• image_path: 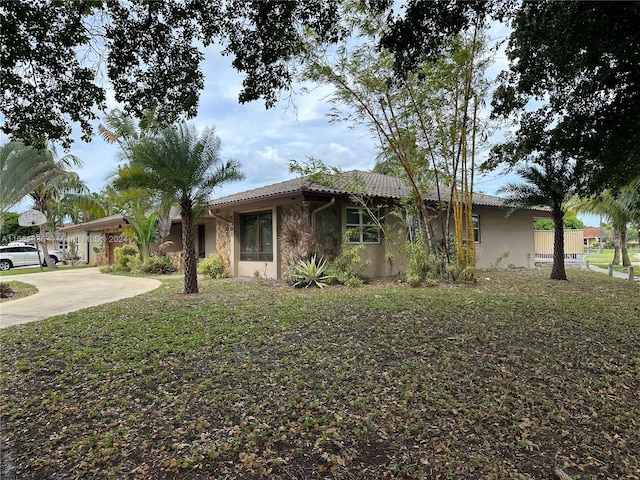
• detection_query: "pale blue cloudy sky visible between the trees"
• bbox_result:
[0,20,597,225]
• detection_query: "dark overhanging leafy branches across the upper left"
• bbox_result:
[0,0,339,148]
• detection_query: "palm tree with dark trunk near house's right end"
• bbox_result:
[500,157,575,280]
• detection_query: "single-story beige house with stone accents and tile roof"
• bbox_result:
[209,171,549,278]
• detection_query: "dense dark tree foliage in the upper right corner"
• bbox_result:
[492,1,640,194]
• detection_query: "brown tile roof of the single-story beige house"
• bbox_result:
[211,170,516,207]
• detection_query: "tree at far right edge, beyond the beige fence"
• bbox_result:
[576,186,640,267]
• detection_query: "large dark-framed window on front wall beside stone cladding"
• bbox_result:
[240,212,273,262]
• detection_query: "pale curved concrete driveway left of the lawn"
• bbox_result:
[0,268,160,328]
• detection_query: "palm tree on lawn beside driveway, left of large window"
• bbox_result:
[113,123,243,294]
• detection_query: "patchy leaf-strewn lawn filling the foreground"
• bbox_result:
[0,270,640,479]
